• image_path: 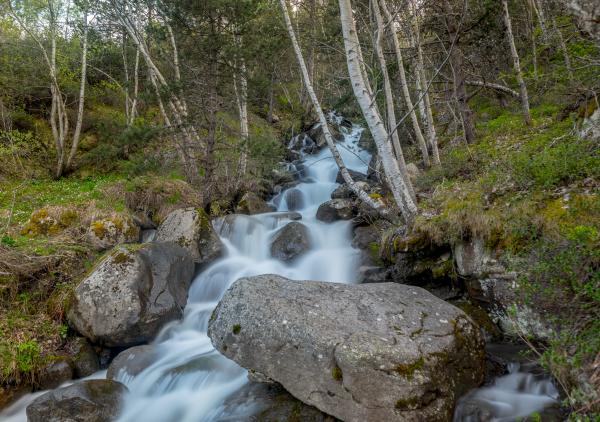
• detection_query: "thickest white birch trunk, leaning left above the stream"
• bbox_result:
[338,0,418,225]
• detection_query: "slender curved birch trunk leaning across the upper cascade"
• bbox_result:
[279,0,386,215]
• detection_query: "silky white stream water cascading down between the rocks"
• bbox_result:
[0,116,552,422]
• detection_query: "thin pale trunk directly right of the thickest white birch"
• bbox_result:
[371,0,416,201]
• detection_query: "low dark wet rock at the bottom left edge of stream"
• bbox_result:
[27,380,127,422]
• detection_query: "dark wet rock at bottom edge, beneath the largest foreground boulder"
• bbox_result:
[217,382,337,422]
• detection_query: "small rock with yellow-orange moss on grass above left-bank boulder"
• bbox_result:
[87,214,140,251]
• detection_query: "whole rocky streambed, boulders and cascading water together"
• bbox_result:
[0,114,560,422]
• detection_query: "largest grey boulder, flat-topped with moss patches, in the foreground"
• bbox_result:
[208,275,484,422]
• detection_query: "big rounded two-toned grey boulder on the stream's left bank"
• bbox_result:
[67,242,194,347]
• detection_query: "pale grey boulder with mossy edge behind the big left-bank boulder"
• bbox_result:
[154,208,224,265]
